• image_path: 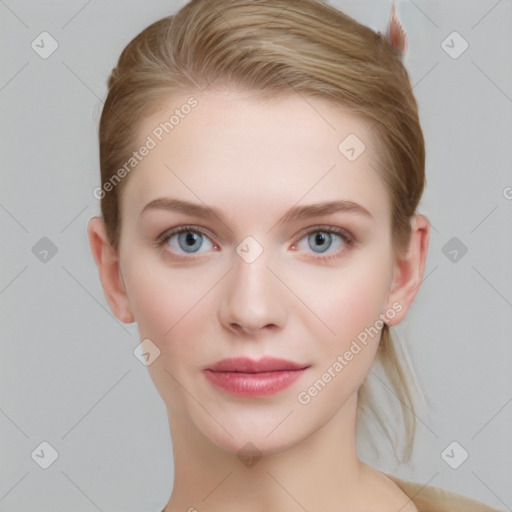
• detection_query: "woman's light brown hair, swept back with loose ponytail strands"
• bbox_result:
[99,0,425,460]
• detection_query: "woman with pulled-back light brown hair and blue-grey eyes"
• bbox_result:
[89,0,504,512]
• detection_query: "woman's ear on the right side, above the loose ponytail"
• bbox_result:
[386,215,430,325]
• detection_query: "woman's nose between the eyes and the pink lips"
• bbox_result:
[218,252,287,335]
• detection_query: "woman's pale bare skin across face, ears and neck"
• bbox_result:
[88,91,430,512]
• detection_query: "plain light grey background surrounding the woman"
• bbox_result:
[0,0,512,512]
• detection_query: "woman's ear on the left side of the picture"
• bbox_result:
[87,217,135,324]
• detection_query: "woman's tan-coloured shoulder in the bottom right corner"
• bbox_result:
[383,473,502,512]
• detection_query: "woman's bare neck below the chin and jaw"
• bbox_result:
[165,394,372,512]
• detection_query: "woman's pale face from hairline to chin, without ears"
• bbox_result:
[114,92,414,453]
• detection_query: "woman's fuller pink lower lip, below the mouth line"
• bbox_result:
[205,368,306,396]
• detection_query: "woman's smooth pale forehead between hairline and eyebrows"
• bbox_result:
[121,92,390,226]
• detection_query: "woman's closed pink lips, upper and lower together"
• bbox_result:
[204,356,309,396]
